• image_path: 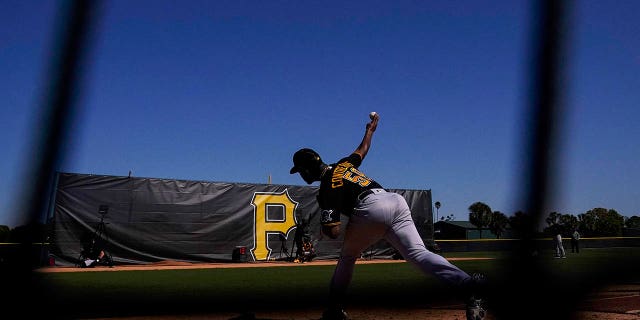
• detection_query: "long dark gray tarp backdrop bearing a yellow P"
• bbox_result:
[50,173,433,265]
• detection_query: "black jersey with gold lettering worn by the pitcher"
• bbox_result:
[318,153,382,215]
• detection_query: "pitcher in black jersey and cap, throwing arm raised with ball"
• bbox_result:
[290,112,485,319]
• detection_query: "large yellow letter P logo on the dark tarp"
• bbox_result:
[250,189,298,261]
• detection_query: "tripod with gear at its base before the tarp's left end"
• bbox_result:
[76,205,113,268]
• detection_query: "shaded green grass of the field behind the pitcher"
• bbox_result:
[35,248,640,318]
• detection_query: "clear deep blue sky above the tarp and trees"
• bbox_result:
[0,0,640,226]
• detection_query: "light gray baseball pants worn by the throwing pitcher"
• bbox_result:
[330,189,470,302]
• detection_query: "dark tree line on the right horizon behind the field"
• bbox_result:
[469,202,640,238]
